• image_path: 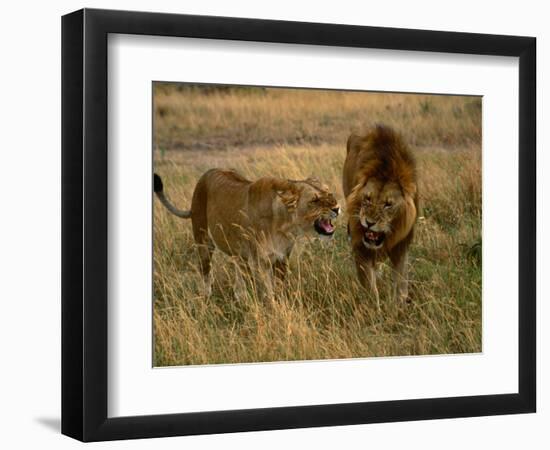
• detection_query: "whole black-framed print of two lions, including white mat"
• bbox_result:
[62,9,536,441]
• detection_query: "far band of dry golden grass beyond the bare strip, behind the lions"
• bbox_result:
[155,84,481,150]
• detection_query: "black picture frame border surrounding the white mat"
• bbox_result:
[62,9,536,441]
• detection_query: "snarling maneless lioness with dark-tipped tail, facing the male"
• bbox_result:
[154,169,340,298]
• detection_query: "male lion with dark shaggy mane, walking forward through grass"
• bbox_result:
[343,125,418,308]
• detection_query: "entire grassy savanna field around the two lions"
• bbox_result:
[154,84,481,366]
